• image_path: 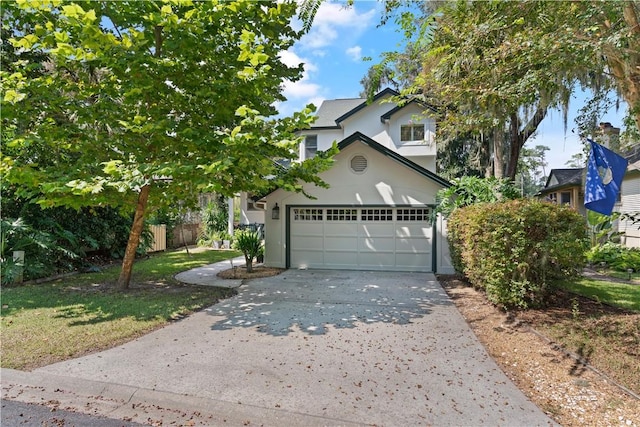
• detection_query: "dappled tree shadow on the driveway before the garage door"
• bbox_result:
[210,270,451,336]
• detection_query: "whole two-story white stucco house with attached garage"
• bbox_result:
[236,89,454,273]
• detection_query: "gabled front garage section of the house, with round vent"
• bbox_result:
[265,133,453,273]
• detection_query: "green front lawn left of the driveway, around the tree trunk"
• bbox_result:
[0,250,240,369]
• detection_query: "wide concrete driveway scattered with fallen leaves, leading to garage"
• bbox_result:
[27,270,553,426]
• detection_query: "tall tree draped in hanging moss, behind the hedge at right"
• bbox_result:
[378,0,640,179]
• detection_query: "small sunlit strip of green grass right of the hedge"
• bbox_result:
[560,277,640,312]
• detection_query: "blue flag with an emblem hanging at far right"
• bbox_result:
[584,139,629,215]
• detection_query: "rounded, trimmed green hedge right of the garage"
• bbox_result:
[448,199,589,308]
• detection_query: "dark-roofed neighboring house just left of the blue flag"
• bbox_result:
[537,168,586,215]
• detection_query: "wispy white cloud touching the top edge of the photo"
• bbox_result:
[300,2,377,49]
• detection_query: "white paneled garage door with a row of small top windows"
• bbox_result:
[289,207,433,271]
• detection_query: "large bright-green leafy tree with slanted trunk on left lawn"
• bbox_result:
[2,0,336,288]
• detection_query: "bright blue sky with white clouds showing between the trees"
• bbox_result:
[277,0,625,174]
